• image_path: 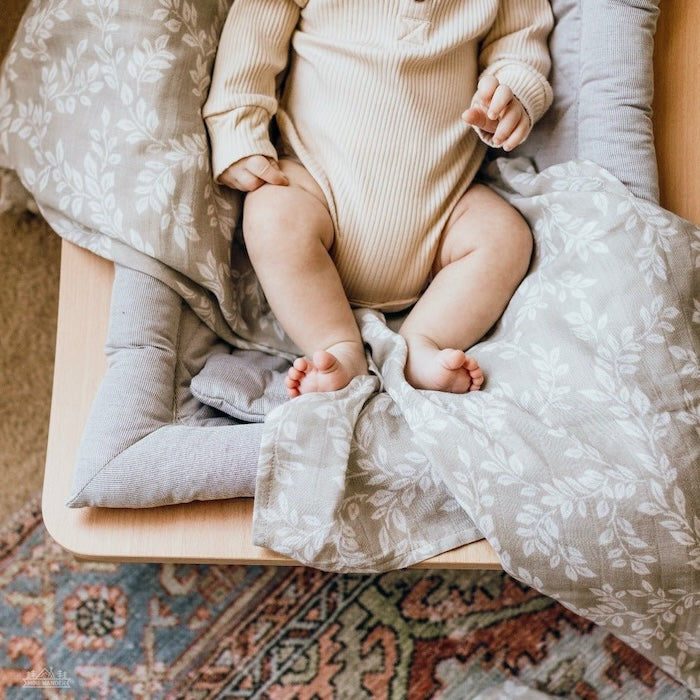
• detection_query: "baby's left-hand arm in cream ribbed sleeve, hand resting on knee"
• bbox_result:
[202,0,307,185]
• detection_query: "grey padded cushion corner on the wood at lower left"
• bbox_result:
[68,265,262,508]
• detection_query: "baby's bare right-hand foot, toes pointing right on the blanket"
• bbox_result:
[405,339,484,394]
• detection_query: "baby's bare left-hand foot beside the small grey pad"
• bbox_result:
[285,343,367,398]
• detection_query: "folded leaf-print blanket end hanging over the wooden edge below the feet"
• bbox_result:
[253,318,481,571]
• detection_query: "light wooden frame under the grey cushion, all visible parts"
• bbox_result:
[42,0,700,569]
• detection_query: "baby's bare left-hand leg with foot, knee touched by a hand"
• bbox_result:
[243,159,367,397]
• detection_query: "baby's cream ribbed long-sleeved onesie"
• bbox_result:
[203,0,552,310]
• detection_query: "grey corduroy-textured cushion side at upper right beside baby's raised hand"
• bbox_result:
[513,0,659,202]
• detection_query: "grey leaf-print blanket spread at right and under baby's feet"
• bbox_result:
[254,159,700,687]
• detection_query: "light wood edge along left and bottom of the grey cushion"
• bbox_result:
[42,241,500,568]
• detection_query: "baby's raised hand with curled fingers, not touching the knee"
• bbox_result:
[462,75,530,151]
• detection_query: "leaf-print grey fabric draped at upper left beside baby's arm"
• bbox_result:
[0,0,294,356]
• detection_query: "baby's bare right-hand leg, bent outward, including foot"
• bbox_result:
[400,185,532,393]
